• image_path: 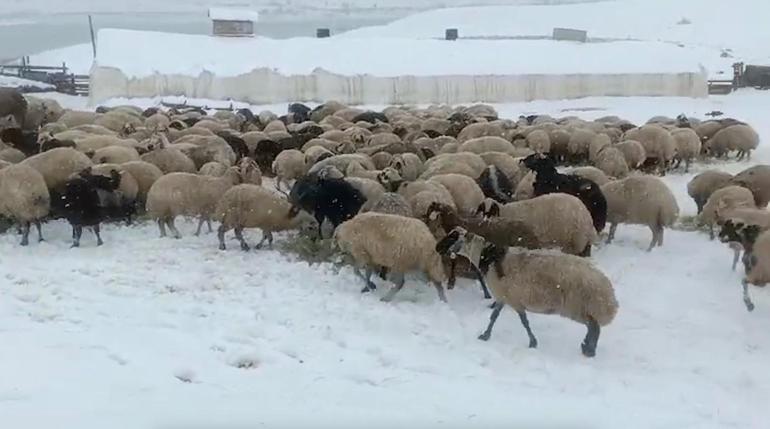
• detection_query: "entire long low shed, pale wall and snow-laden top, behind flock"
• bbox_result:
[91,30,707,104]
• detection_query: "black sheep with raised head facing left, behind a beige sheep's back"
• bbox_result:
[521,154,607,232]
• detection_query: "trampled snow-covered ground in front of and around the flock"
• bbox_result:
[0,91,770,429]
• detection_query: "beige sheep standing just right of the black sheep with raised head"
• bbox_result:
[601,175,679,252]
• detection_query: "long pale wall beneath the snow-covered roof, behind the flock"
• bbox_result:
[91,67,708,104]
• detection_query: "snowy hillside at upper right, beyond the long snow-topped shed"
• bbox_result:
[337,0,770,76]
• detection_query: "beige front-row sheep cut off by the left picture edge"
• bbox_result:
[0,164,51,246]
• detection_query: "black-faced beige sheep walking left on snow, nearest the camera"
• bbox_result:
[439,230,618,357]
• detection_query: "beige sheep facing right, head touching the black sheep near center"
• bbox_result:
[215,183,318,251]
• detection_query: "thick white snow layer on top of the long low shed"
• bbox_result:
[96,29,700,77]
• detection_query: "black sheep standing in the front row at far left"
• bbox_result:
[61,168,120,247]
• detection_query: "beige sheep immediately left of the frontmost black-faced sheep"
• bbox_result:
[334,212,446,302]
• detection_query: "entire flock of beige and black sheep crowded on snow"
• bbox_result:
[0,89,770,357]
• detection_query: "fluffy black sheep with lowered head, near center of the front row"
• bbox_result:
[289,175,366,239]
